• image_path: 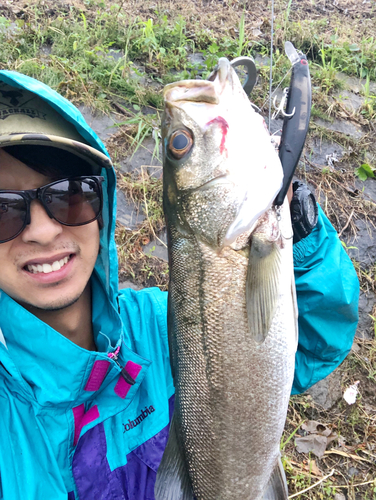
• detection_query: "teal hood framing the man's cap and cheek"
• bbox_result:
[0,71,118,308]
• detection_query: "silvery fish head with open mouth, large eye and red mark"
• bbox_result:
[162,58,283,246]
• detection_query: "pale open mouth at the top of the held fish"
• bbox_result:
[163,57,237,104]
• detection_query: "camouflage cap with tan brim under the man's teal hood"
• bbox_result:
[0,82,112,174]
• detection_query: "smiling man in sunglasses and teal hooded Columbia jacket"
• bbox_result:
[0,71,358,500]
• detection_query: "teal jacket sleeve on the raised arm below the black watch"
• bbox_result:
[292,206,359,394]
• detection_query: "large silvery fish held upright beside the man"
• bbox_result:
[154,58,297,500]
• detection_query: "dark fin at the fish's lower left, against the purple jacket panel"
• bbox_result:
[154,413,194,500]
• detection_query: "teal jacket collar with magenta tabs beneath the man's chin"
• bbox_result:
[0,275,150,408]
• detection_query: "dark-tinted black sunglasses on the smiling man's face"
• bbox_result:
[0,175,104,243]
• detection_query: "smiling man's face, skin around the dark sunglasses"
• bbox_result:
[0,149,99,310]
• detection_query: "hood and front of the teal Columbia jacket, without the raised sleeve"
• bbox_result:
[0,71,174,500]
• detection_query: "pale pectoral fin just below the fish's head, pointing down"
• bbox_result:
[246,235,281,342]
